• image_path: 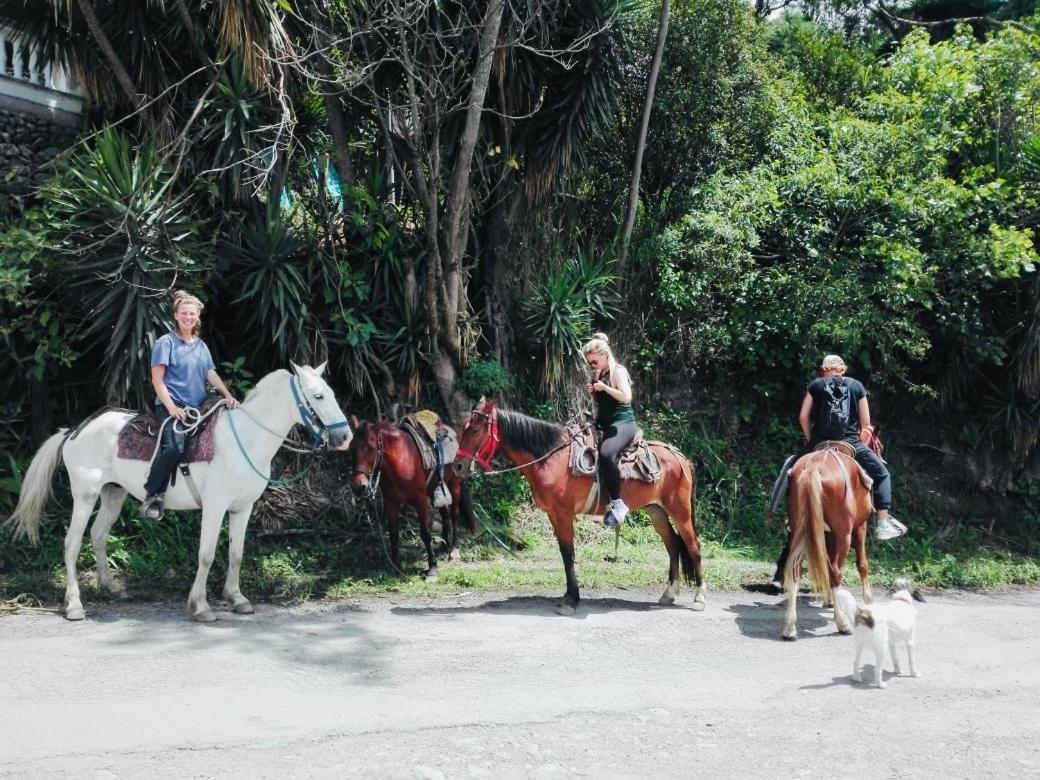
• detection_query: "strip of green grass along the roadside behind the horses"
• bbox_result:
[0,434,1040,605]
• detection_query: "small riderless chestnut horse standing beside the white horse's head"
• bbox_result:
[347,417,476,579]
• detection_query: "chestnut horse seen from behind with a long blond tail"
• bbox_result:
[783,442,874,640]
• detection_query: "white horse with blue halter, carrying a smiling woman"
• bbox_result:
[6,363,352,623]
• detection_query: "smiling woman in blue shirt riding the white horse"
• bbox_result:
[140,290,238,520]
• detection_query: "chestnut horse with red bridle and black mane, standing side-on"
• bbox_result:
[456,400,705,615]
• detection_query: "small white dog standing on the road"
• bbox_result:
[848,578,925,687]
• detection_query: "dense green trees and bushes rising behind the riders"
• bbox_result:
[0,0,1040,599]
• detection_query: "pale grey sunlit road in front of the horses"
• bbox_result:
[0,591,1040,779]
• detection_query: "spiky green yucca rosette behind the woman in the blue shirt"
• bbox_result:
[41,128,211,404]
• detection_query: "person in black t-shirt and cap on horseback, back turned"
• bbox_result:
[765,355,907,586]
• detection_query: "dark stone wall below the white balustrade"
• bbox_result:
[0,109,79,200]
